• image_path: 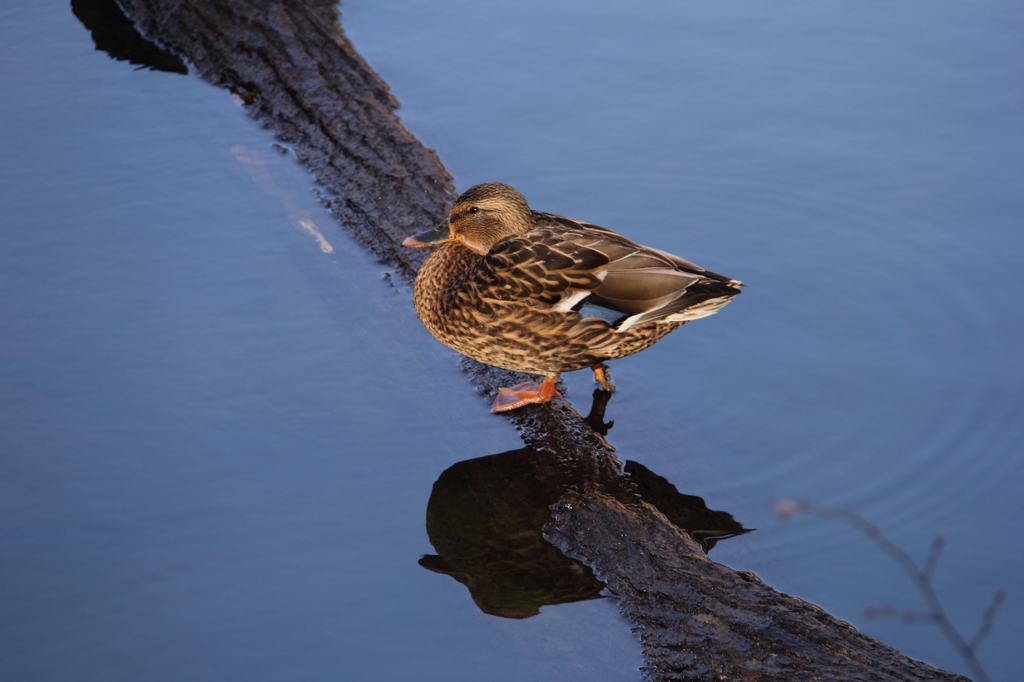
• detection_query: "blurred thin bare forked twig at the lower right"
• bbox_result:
[775,500,1006,682]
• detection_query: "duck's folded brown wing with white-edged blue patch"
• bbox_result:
[483,213,740,331]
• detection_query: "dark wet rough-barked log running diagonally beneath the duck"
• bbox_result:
[121,0,967,681]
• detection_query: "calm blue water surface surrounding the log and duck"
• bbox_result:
[0,1,1024,680]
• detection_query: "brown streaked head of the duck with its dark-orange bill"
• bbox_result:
[401,182,534,256]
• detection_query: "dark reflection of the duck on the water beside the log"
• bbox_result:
[420,390,750,619]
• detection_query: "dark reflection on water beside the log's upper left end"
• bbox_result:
[71,0,188,74]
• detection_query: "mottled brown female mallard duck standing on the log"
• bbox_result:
[402,182,742,412]
